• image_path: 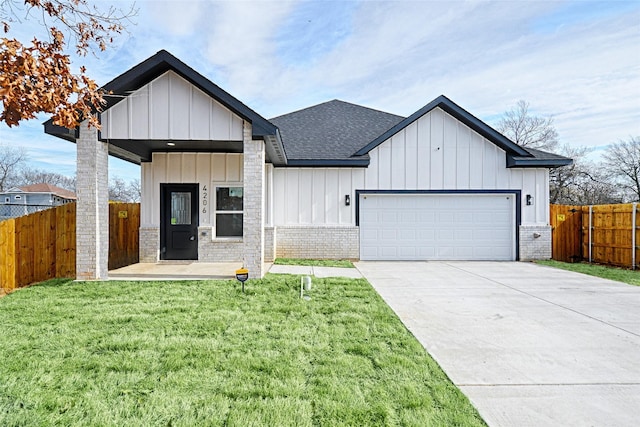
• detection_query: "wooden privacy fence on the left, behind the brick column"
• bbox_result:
[0,203,140,291]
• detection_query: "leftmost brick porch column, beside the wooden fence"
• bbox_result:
[76,121,109,280]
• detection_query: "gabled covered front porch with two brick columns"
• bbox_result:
[45,51,286,280]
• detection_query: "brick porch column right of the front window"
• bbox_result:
[242,122,265,279]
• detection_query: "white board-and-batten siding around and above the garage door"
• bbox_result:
[273,108,549,226]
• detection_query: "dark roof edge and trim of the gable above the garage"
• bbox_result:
[354,95,572,167]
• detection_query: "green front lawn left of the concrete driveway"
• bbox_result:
[0,275,485,427]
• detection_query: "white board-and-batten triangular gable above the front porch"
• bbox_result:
[102,71,242,141]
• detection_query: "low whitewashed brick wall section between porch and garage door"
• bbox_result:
[275,226,360,259]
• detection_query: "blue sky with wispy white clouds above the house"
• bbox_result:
[0,0,640,179]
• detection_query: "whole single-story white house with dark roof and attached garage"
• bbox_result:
[45,51,571,278]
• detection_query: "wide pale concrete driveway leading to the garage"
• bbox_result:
[356,262,640,427]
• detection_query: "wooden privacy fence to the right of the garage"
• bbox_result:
[550,203,640,269]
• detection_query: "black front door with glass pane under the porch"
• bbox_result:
[160,184,198,260]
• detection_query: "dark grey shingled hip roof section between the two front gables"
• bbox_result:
[270,99,403,166]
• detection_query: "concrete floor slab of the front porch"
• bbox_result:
[109,261,252,280]
